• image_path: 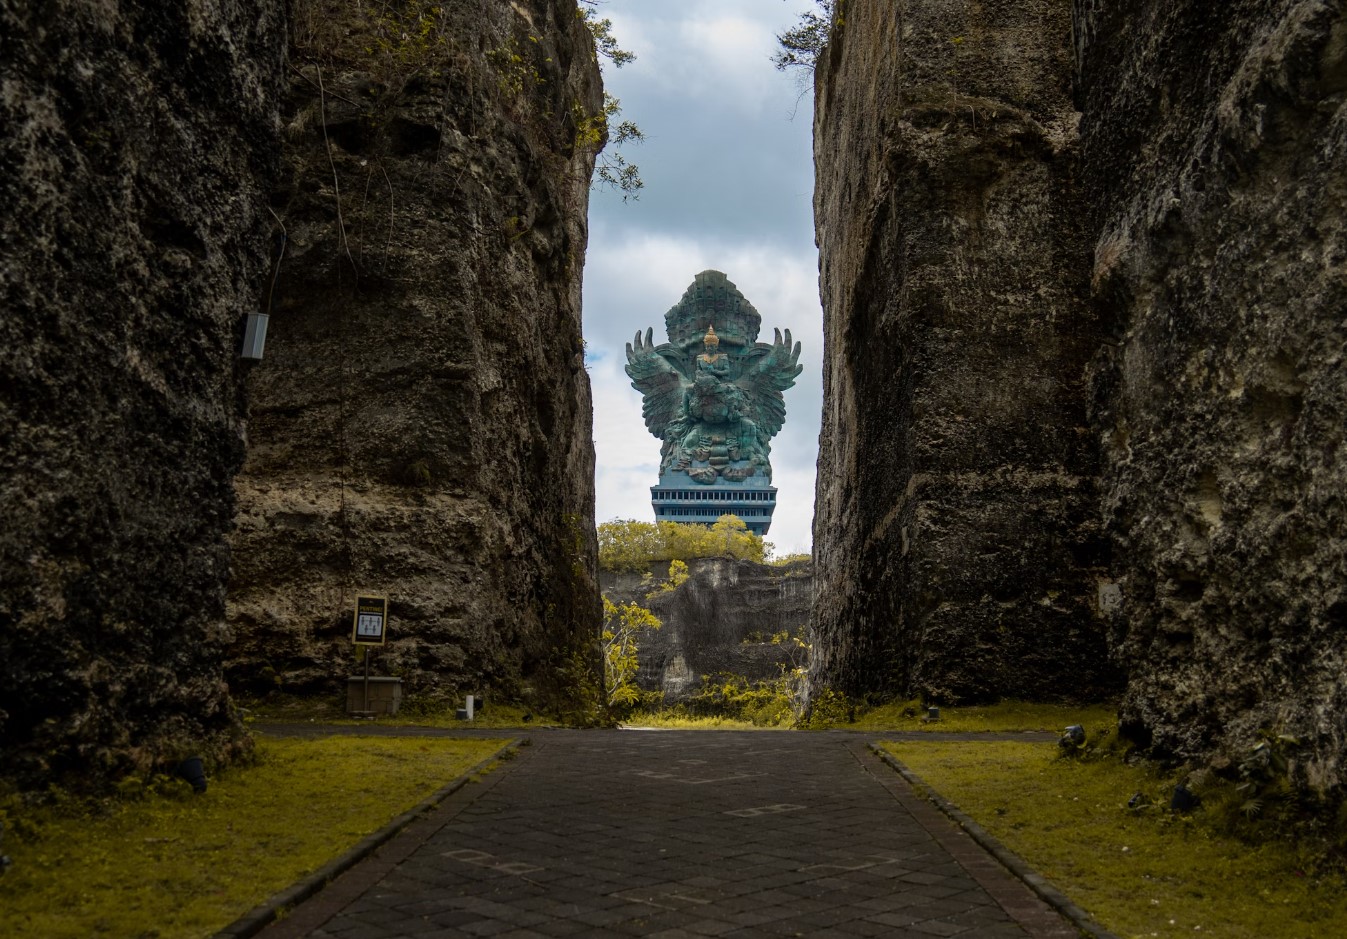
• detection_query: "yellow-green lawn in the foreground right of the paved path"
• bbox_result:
[884,741,1347,939]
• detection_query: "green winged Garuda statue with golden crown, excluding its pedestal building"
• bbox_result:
[626,271,803,485]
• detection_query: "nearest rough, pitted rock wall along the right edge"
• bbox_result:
[1076,0,1347,788]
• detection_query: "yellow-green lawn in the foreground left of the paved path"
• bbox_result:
[0,737,505,939]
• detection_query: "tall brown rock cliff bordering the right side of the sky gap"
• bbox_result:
[812,0,1115,703]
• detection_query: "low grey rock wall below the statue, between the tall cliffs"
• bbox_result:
[601,558,814,705]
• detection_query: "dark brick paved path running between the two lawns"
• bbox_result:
[261,732,1076,939]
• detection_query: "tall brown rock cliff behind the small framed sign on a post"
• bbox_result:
[229,0,602,711]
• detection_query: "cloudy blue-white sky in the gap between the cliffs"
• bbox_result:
[585,0,823,555]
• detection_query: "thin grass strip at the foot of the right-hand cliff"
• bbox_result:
[834,701,1118,733]
